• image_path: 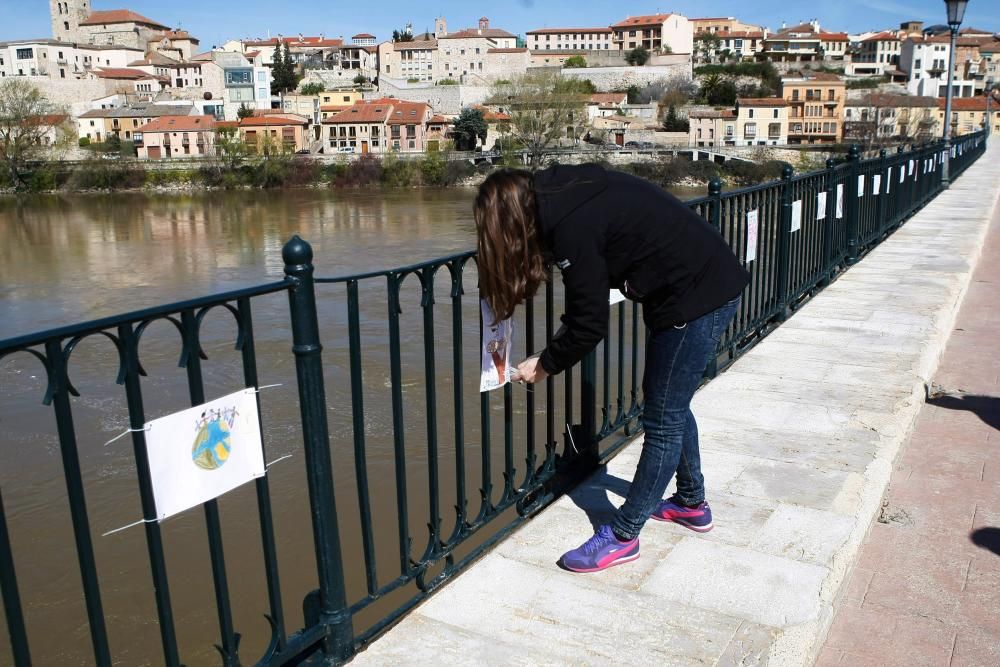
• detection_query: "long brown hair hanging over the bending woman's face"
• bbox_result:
[474,169,548,324]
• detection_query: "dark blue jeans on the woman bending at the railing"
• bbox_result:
[611,297,740,539]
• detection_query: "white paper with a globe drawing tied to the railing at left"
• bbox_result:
[145,389,265,521]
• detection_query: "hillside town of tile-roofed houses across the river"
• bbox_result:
[0,0,1000,183]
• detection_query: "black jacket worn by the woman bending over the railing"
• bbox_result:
[535,164,750,373]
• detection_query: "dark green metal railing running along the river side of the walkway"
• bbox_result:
[0,133,985,667]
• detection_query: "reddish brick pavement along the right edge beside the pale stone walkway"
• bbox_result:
[817,168,1000,667]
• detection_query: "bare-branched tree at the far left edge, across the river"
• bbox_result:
[0,77,68,189]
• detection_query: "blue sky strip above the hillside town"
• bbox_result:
[0,0,1000,49]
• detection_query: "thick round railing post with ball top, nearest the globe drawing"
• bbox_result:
[281,235,354,663]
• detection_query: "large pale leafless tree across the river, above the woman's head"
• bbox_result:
[488,72,593,168]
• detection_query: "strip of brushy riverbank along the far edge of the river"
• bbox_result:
[0,153,796,195]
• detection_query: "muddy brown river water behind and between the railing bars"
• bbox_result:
[0,184,699,665]
